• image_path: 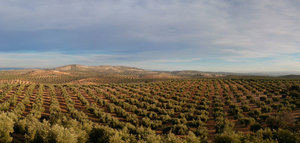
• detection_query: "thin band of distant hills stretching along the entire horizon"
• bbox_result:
[0,64,300,77]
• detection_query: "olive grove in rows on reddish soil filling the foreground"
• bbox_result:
[0,78,300,142]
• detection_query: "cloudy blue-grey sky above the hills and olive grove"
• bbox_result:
[0,0,300,72]
